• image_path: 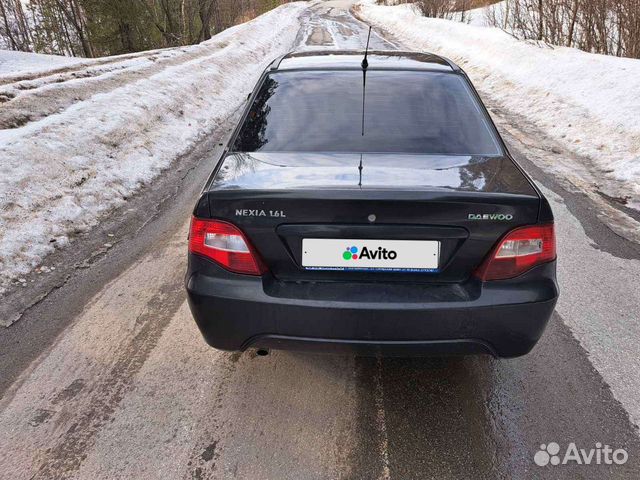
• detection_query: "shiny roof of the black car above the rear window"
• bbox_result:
[270,50,460,72]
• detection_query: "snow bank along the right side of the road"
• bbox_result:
[356,0,640,198]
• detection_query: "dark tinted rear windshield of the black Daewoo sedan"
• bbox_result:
[234,70,500,156]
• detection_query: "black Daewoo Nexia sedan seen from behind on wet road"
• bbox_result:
[186,51,558,357]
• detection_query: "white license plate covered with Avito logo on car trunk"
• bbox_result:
[302,238,440,272]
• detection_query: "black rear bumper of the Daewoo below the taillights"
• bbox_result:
[186,255,558,357]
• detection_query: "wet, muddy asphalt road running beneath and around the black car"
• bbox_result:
[0,1,640,480]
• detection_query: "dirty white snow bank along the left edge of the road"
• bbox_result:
[0,3,306,293]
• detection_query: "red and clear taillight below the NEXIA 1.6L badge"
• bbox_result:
[189,217,267,275]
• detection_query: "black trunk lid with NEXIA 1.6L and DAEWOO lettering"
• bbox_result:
[207,153,540,282]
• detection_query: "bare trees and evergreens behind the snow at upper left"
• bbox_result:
[0,0,292,57]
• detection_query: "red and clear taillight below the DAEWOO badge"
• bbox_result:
[475,224,556,282]
